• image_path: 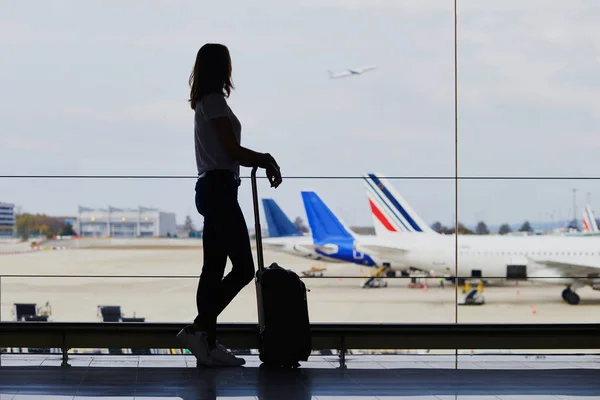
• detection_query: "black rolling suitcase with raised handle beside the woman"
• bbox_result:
[251,167,312,367]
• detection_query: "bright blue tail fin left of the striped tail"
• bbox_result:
[302,192,354,243]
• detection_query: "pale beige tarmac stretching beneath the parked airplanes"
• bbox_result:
[0,246,600,323]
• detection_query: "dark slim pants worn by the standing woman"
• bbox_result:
[194,171,254,345]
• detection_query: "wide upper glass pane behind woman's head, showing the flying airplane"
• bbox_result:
[0,0,453,175]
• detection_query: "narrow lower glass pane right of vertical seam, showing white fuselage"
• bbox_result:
[458,180,600,323]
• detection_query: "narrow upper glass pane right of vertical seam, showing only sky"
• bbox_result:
[458,1,600,177]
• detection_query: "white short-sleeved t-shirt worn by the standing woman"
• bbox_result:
[194,93,242,177]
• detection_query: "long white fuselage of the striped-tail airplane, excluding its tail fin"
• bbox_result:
[359,233,600,284]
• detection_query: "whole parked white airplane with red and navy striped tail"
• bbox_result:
[357,174,600,305]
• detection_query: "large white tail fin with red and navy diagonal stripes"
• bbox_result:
[363,174,435,235]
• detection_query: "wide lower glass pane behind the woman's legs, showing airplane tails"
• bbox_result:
[0,175,455,322]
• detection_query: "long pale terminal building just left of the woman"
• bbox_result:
[77,206,177,238]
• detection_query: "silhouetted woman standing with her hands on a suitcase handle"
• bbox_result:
[177,43,282,366]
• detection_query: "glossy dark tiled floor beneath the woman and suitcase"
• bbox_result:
[0,355,600,400]
